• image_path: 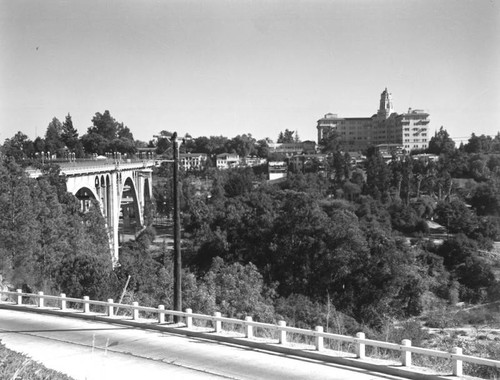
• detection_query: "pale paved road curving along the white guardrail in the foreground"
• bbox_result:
[0,309,406,380]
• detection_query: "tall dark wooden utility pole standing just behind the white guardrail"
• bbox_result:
[171,132,182,323]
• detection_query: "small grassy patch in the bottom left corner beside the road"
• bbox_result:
[0,341,73,380]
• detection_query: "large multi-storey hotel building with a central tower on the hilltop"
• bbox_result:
[317,88,429,152]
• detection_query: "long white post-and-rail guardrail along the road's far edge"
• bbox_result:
[0,289,500,376]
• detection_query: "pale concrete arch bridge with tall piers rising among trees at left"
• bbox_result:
[28,159,156,262]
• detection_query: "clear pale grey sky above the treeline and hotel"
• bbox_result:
[0,0,500,143]
